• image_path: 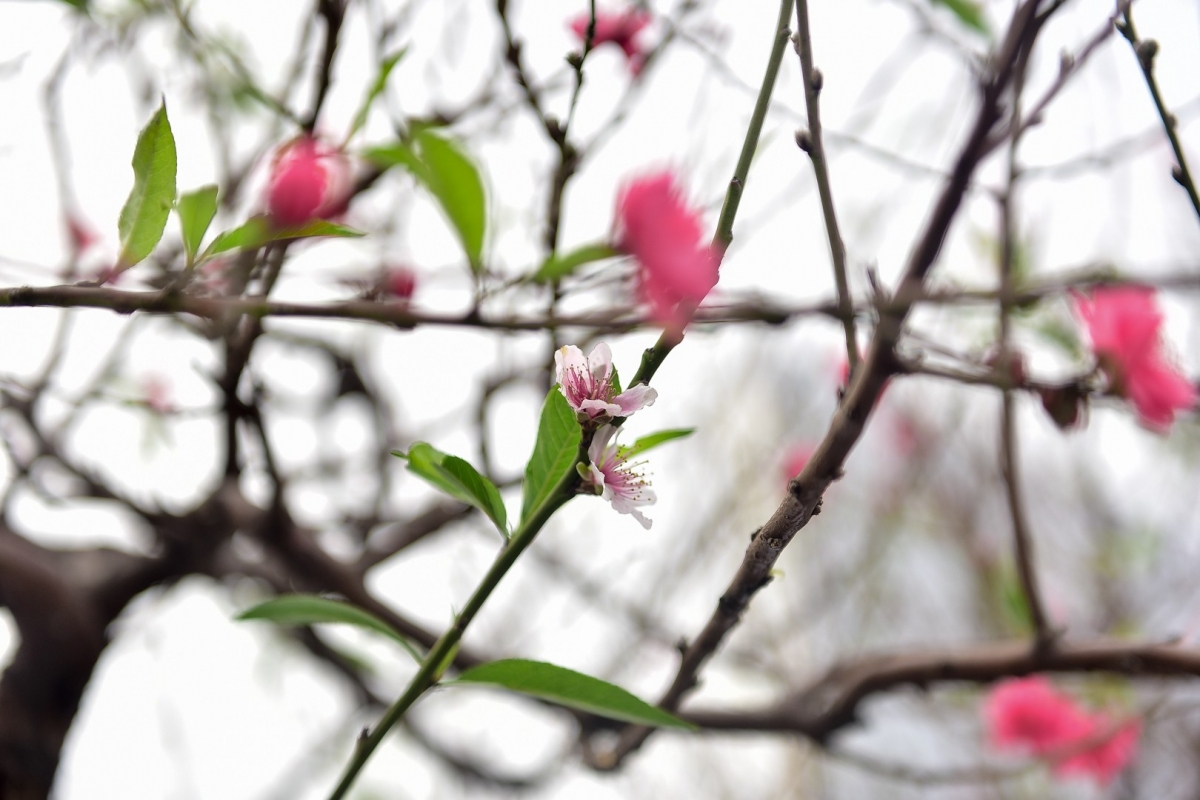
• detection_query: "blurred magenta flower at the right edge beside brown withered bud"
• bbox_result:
[1074,287,1196,433]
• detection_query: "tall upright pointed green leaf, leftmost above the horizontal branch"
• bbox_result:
[116,103,176,269]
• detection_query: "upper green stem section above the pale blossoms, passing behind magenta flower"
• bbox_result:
[629,0,794,386]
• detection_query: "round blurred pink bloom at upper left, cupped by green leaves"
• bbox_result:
[266,136,350,228]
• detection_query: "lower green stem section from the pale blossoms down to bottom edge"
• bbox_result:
[329,434,592,800]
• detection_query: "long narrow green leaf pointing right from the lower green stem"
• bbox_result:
[446,658,696,730]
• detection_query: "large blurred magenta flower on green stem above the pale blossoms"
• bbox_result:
[616,172,721,336]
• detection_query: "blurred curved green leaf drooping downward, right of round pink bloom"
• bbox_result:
[365,130,487,272]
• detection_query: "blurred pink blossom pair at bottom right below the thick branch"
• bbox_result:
[984,675,1141,784]
